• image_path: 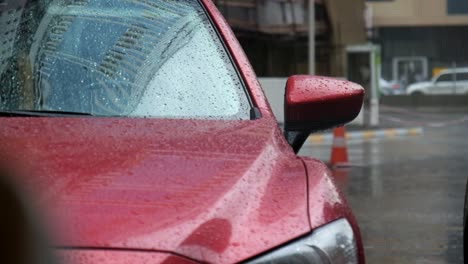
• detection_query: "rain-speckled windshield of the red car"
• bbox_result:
[0,0,250,119]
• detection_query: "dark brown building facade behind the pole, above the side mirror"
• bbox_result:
[214,0,366,77]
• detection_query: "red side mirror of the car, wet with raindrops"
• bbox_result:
[284,75,364,153]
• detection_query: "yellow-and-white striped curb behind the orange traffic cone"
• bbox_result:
[307,127,424,144]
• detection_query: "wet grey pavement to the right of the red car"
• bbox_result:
[300,108,468,264]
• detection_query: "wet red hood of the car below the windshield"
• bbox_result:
[0,117,310,263]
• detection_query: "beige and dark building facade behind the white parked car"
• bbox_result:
[367,0,468,85]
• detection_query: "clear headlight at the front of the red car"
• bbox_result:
[247,219,358,264]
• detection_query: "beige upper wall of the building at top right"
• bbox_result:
[367,0,468,27]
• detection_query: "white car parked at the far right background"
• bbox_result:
[406,68,468,95]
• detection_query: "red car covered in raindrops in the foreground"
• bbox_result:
[0,0,364,264]
